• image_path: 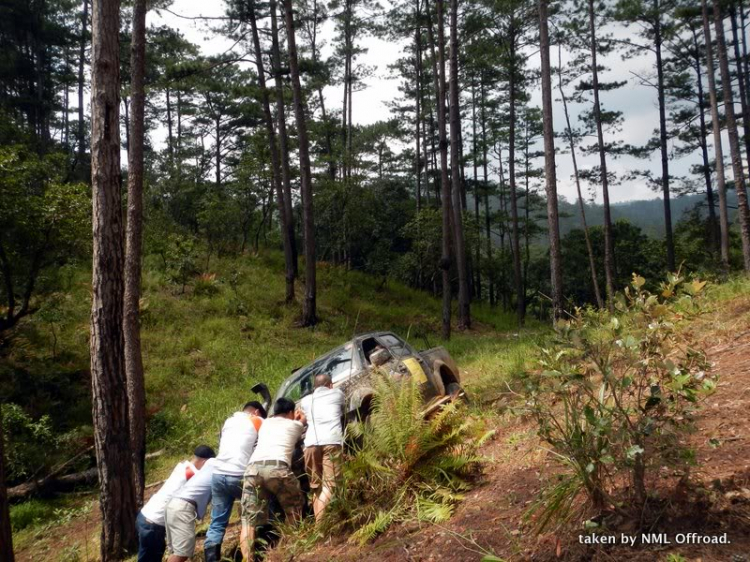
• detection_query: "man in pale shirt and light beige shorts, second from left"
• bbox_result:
[164,459,216,562]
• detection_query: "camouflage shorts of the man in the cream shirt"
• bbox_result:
[240,464,304,527]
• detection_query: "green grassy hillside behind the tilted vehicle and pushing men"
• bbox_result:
[5,253,542,553]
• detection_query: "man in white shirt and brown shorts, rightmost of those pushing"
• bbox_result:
[300,374,346,521]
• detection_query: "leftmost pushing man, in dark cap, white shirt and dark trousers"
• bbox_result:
[135,445,216,562]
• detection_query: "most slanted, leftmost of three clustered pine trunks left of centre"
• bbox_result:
[248,0,295,303]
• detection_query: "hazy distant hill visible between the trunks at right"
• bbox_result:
[560,191,737,238]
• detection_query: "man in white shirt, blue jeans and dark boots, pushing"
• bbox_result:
[203,400,266,562]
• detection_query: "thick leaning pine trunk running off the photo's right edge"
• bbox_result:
[713,0,750,272]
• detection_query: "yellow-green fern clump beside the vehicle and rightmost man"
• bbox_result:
[325,375,492,543]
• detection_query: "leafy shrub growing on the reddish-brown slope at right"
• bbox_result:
[528,274,716,530]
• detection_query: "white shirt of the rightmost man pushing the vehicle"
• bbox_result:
[299,386,346,447]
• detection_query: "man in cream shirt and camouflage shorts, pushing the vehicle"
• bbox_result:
[238,398,305,562]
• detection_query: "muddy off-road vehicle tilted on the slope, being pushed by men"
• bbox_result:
[252,332,465,421]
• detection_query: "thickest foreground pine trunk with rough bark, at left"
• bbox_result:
[91,0,138,562]
